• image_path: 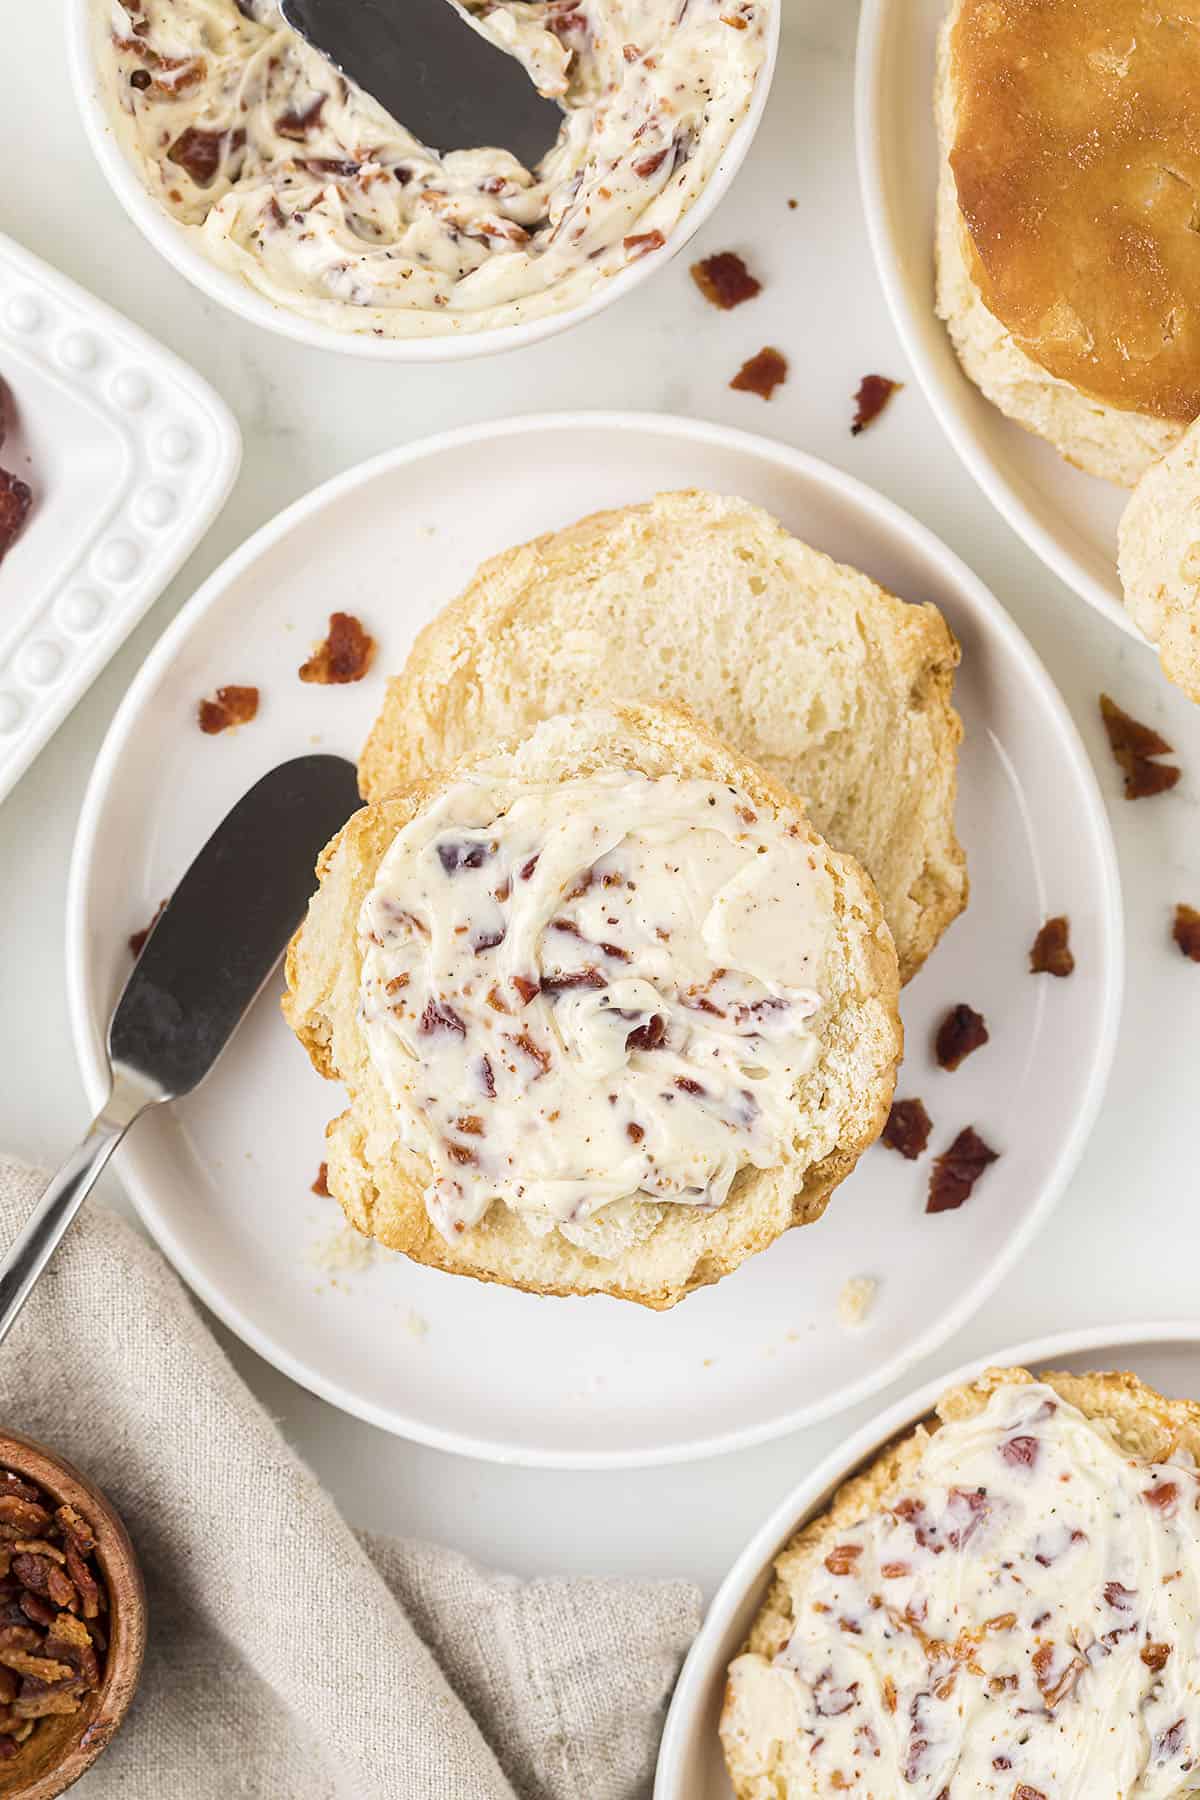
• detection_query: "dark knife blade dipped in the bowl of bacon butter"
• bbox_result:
[281,0,563,169]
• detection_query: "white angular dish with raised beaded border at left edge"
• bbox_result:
[0,234,241,797]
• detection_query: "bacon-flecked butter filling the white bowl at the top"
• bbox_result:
[94,0,774,337]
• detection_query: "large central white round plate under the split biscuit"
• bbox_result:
[68,414,1121,1467]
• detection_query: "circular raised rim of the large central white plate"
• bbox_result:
[67,410,1124,1469]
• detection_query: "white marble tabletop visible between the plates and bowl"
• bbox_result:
[0,0,1200,1586]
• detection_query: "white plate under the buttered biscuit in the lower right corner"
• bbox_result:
[653,1319,1200,1800]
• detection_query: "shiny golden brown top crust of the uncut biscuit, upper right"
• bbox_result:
[950,0,1200,423]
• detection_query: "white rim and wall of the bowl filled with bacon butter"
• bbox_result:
[67,0,783,362]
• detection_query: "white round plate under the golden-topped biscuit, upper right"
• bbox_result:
[855,0,1144,643]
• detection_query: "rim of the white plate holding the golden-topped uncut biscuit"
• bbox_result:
[855,0,1148,644]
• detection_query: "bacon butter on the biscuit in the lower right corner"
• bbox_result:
[734,1382,1200,1800]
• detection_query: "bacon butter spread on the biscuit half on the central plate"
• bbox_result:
[360,772,833,1247]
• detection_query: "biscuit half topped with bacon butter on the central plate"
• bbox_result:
[284,707,901,1309]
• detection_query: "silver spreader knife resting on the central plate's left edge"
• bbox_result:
[0,756,360,1341]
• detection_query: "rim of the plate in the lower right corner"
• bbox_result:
[653,1319,1200,1800]
